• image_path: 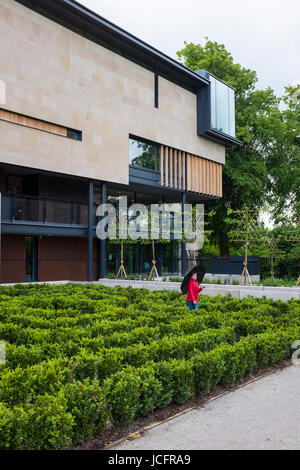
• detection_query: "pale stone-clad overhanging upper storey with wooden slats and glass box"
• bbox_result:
[0,0,237,197]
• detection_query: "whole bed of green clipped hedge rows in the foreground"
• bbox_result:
[0,284,300,449]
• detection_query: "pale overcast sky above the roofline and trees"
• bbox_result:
[80,0,300,95]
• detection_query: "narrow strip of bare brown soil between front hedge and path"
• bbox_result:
[72,359,292,450]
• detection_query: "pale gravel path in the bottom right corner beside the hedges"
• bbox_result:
[113,365,300,450]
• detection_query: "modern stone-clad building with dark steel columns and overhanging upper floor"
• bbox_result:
[0,0,238,283]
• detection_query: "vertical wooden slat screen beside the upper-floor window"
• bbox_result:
[160,145,222,197]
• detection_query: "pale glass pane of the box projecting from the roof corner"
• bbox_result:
[209,75,235,137]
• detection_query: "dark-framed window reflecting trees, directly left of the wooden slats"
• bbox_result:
[129,138,160,171]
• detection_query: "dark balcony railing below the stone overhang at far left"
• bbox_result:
[2,195,97,227]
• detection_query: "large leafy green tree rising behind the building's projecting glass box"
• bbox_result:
[177,38,299,256]
